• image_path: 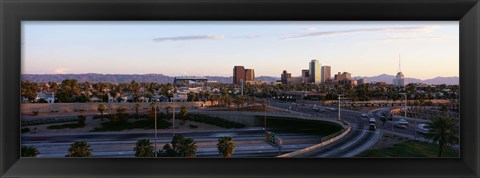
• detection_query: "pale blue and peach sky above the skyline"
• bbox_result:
[21,21,459,80]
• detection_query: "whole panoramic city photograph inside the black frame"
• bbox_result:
[18,21,461,159]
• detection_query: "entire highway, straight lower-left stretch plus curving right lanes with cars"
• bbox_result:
[22,100,436,157]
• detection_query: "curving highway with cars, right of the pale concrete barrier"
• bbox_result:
[270,100,427,157]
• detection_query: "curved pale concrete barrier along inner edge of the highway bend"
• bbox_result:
[276,122,352,158]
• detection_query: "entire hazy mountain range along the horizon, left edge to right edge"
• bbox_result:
[21,73,459,85]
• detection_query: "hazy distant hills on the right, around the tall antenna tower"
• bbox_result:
[354,74,460,85]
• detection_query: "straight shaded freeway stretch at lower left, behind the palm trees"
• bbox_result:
[22,128,321,157]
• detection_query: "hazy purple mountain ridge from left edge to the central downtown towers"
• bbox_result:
[21,73,278,83]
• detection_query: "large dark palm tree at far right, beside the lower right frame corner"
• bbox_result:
[425,116,459,157]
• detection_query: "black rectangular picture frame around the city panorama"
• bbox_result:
[0,0,480,177]
